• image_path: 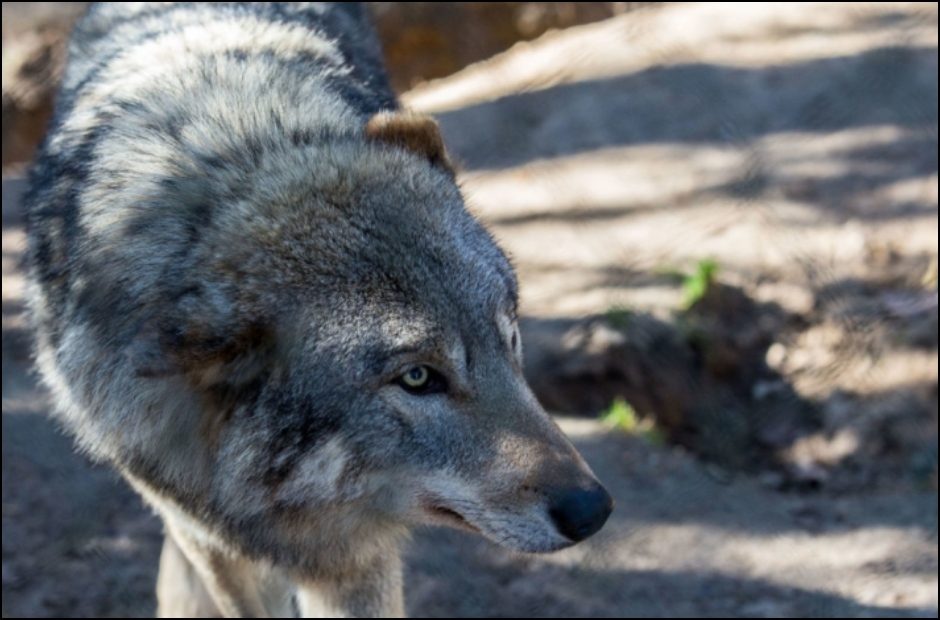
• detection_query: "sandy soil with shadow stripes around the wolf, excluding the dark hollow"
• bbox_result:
[3,4,938,617]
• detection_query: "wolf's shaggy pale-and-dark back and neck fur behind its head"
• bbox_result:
[25,3,397,456]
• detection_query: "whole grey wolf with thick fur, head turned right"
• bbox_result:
[25,3,612,616]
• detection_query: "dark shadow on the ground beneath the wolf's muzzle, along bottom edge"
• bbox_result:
[406,530,935,618]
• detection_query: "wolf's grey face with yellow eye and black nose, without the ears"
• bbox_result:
[231,117,612,552]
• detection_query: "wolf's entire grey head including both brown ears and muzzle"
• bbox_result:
[129,113,612,564]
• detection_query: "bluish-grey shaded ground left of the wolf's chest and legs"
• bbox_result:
[3,400,162,617]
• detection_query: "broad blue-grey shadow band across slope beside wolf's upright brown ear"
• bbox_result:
[438,46,937,170]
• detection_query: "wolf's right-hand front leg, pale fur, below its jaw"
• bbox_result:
[297,554,405,618]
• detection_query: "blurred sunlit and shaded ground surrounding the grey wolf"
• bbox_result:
[2,2,938,617]
